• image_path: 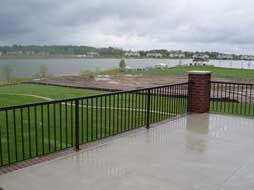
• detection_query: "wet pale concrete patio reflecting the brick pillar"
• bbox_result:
[0,114,254,190]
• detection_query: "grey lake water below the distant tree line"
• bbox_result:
[0,59,254,78]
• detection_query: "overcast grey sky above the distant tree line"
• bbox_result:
[0,0,254,54]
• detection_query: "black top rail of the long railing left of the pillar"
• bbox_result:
[0,82,189,111]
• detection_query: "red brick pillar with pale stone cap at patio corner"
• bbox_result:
[188,71,211,113]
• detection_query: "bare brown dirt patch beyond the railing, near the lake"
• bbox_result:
[29,75,236,90]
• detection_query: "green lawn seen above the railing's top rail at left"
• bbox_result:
[0,84,103,107]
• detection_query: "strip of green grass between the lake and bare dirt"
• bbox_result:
[126,66,254,78]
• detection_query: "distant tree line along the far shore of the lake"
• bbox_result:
[0,45,240,59]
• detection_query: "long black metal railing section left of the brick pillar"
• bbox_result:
[0,83,188,167]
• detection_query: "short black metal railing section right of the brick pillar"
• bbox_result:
[210,81,254,116]
